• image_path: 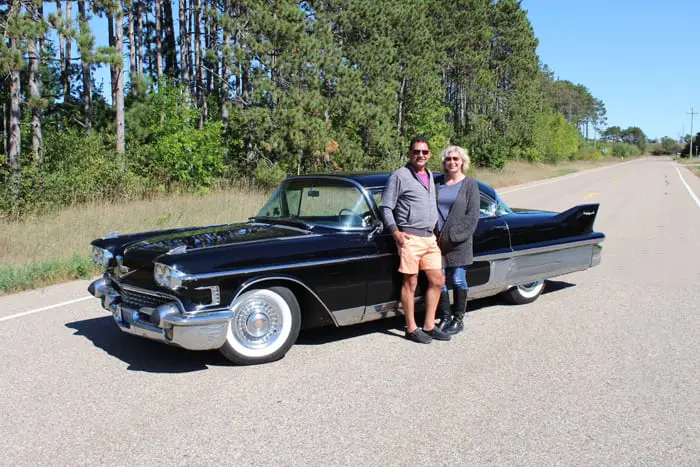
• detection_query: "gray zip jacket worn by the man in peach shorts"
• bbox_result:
[379,164,438,237]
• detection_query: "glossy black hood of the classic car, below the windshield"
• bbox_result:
[124,222,310,267]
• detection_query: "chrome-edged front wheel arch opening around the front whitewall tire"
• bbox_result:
[230,275,338,329]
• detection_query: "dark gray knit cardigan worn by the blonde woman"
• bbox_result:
[436,177,481,268]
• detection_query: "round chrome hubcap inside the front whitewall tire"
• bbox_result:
[232,299,284,349]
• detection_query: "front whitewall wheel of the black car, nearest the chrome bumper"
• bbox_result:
[219,287,301,365]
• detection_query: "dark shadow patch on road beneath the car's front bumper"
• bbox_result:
[66,316,229,373]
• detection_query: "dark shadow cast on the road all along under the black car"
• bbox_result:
[66,281,575,373]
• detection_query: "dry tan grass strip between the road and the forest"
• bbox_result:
[0,159,619,294]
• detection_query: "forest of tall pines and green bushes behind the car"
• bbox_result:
[0,0,624,217]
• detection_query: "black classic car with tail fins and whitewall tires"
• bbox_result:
[89,174,605,364]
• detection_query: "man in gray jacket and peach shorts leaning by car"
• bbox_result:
[379,136,450,344]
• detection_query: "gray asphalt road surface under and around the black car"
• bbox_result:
[0,159,700,465]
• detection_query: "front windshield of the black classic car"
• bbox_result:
[256,178,375,229]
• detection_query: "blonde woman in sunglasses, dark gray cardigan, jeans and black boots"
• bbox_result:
[436,146,479,334]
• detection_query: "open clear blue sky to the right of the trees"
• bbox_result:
[522,0,700,138]
